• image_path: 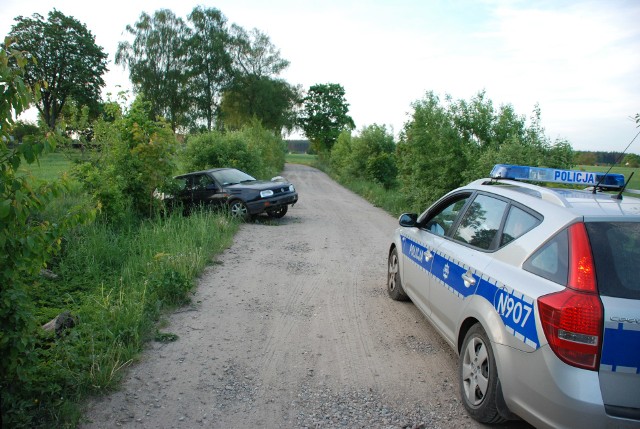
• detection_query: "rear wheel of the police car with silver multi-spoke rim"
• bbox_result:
[458,323,507,424]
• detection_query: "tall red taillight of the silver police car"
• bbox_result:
[538,223,603,370]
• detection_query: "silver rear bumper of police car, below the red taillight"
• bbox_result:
[494,344,640,428]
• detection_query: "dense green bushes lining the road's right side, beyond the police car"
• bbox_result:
[330,92,573,211]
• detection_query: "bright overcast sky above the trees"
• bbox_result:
[0,0,640,153]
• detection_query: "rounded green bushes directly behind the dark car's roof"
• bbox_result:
[182,122,285,178]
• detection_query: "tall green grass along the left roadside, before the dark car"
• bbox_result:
[10,211,238,427]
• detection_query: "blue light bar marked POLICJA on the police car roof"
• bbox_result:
[491,164,625,189]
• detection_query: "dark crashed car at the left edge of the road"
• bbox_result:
[165,168,298,220]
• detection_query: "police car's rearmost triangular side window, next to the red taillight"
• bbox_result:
[522,229,569,285]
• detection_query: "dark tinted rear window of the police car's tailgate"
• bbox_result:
[586,222,640,299]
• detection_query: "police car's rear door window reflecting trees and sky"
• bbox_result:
[453,195,508,250]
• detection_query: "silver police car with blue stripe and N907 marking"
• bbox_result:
[387,165,640,428]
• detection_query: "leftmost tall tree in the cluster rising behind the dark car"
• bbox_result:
[116,9,192,131]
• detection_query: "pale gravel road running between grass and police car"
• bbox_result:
[82,165,528,428]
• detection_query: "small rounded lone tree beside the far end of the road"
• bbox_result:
[300,83,355,152]
